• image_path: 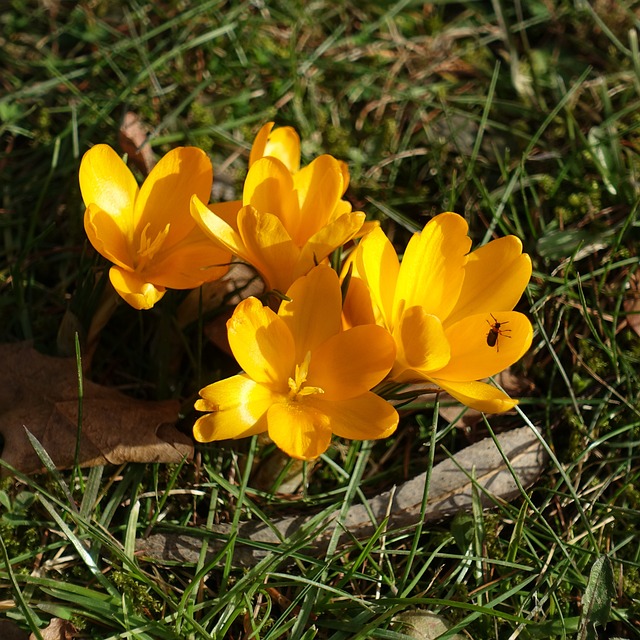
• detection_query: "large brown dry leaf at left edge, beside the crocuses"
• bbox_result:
[0,343,193,475]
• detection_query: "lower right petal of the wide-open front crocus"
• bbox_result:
[313,392,399,440]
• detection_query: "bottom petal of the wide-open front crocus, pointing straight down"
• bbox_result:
[267,402,331,460]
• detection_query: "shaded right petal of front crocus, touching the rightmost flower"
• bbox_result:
[307,324,396,402]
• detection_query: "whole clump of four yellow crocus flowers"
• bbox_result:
[80,123,533,460]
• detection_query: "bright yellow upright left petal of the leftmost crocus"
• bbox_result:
[79,144,138,237]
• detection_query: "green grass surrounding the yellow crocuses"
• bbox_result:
[0,0,640,640]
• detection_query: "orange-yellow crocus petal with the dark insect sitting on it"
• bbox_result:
[434,311,533,381]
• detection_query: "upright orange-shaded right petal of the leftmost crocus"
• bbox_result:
[134,147,213,244]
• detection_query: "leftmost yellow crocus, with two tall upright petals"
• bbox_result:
[80,144,231,309]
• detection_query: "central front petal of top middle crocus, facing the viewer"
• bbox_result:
[238,206,300,292]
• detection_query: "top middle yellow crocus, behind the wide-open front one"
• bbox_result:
[191,123,365,292]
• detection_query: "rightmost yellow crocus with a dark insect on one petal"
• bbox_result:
[345,213,533,413]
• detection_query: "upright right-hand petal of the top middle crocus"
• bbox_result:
[291,155,343,247]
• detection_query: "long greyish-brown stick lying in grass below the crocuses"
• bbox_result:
[138,427,547,565]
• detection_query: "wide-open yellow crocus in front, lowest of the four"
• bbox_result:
[193,265,398,460]
